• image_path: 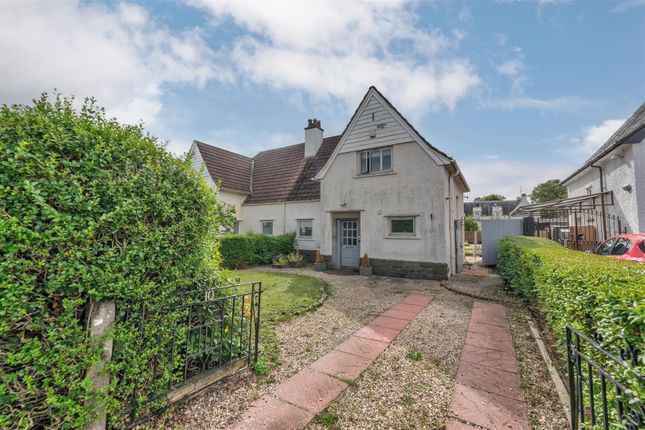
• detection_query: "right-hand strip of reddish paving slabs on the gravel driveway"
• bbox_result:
[446,301,530,430]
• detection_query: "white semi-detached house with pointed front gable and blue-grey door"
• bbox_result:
[192,87,469,279]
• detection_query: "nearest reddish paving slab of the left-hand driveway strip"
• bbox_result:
[231,394,314,430]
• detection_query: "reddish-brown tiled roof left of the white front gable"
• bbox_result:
[195,136,340,204]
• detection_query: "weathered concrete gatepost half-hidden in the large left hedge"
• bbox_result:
[85,302,116,430]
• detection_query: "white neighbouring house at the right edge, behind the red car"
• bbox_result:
[562,103,645,233]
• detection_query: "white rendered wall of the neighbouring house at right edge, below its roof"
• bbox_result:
[567,142,645,233]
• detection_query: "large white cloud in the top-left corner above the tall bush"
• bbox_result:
[0,2,232,124]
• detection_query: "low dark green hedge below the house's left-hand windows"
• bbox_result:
[219,233,296,268]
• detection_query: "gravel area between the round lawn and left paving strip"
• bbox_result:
[149,267,445,429]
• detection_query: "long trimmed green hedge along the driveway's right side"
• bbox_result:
[497,237,645,398]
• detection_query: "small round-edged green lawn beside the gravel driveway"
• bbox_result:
[230,270,328,322]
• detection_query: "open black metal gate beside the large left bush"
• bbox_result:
[114,282,262,427]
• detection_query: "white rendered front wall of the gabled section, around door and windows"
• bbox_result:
[320,142,450,264]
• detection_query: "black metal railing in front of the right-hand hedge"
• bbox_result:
[566,326,645,430]
